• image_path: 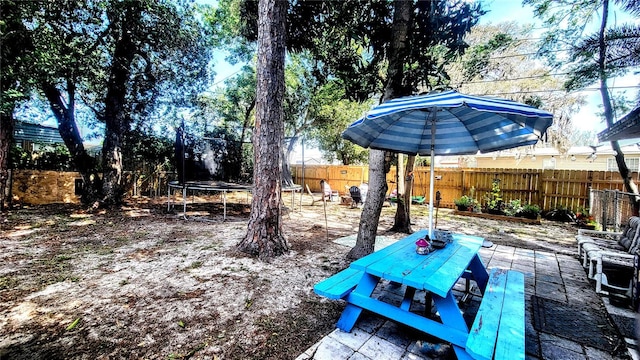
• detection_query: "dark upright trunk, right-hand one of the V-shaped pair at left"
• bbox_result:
[102,2,142,206]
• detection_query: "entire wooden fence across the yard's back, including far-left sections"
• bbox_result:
[10,165,638,211]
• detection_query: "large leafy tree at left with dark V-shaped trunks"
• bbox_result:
[3,0,210,204]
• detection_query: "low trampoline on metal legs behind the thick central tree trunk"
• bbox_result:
[167,181,302,220]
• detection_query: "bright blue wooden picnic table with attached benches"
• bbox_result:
[314,230,524,359]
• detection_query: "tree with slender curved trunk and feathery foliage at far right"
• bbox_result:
[524,0,640,213]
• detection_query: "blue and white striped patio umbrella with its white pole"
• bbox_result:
[342,91,553,236]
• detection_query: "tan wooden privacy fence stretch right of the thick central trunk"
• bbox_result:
[291,164,638,211]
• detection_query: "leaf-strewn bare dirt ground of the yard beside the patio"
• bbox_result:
[0,195,576,359]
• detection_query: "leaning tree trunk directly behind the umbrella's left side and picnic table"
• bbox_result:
[347,0,413,259]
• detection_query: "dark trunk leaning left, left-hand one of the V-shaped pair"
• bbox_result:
[41,81,100,205]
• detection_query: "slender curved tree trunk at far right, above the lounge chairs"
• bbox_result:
[598,0,640,215]
